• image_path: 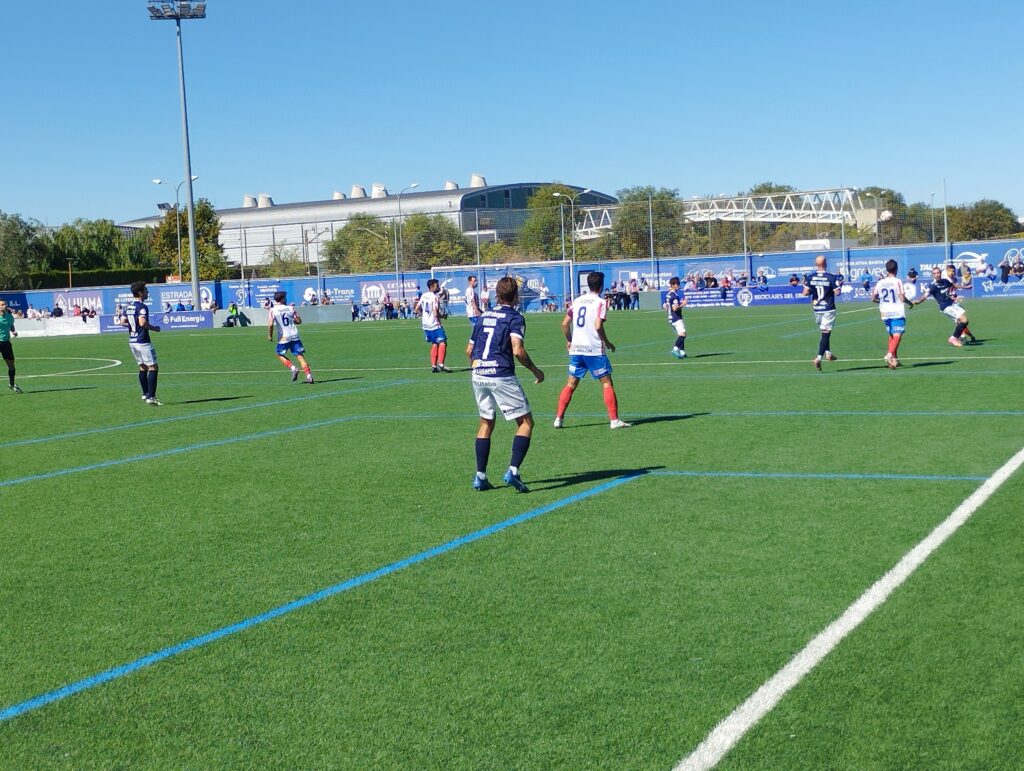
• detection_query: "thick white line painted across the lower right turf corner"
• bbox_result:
[676,449,1024,771]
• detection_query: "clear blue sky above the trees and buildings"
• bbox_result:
[0,0,1024,224]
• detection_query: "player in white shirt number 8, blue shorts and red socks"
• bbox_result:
[555,271,631,428]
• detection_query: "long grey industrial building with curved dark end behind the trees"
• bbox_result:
[122,174,617,267]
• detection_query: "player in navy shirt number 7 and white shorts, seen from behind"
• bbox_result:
[466,276,544,492]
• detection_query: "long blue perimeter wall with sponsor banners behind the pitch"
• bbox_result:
[0,240,1024,313]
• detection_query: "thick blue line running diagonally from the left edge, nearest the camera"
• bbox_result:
[0,471,646,723]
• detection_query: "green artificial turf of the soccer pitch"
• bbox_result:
[0,300,1024,769]
